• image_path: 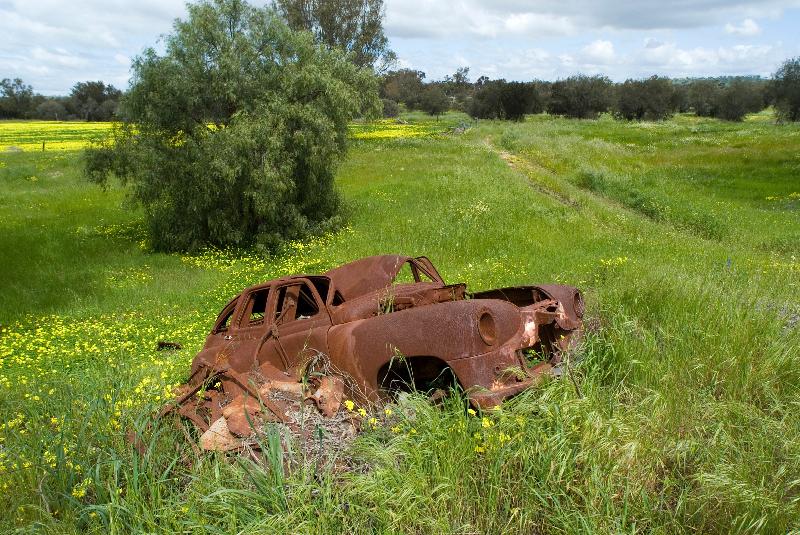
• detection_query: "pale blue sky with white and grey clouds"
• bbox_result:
[0,0,800,94]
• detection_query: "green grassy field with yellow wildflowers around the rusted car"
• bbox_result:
[0,114,800,534]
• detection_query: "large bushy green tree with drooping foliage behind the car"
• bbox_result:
[86,0,380,250]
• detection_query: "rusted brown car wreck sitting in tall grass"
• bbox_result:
[169,255,583,450]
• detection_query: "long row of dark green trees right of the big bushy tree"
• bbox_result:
[381,57,800,121]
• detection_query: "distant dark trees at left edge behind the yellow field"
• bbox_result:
[0,78,122,121]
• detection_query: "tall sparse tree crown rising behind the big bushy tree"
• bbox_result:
[275,0,397,72]
